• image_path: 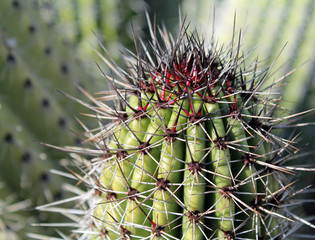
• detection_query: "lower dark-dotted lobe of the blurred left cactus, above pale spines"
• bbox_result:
[0,103,61,202]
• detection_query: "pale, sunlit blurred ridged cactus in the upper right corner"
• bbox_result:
[190,0,315,111]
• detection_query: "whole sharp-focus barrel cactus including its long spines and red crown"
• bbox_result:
[39,17,314,240]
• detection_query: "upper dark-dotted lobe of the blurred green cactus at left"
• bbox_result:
[0,0,99,148]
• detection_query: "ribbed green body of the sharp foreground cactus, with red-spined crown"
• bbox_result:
[85,32,286,239]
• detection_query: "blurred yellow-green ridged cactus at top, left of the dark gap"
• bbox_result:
[41,0,144,61]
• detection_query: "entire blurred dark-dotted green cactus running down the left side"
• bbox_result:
[0,0,102,239]
